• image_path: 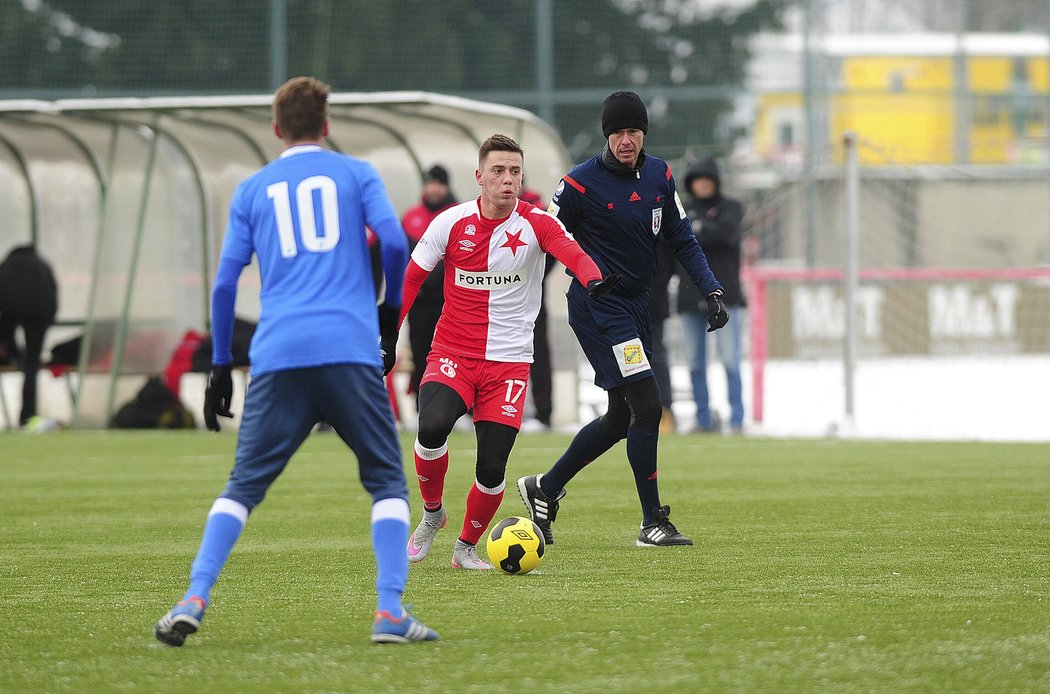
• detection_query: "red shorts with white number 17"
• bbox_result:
[419,349,529,430]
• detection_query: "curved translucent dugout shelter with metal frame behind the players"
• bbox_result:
[0,91,571,426]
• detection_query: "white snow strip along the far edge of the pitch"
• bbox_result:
[10,355,1050,442]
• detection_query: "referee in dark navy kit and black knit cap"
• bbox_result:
[518,91,729,547]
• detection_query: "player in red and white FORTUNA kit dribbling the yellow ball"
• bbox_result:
[401,134,620,569]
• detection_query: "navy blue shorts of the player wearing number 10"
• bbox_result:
[219,364,408,510]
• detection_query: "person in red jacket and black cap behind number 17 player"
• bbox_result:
[401,164,457,399]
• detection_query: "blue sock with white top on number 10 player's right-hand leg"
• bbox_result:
[372,499,408,617]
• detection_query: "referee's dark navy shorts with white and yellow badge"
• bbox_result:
[566,281,653,391]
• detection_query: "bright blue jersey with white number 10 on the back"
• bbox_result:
[222,145,404,374]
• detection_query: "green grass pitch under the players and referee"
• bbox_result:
[0,432,1050,693]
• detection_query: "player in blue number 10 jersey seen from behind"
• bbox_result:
[154,77,438,646]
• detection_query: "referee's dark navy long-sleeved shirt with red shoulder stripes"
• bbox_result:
[548,154,720,296]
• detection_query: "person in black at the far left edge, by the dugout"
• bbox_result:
[0,245,59,426]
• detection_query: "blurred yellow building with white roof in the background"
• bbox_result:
[754,34,1050,165]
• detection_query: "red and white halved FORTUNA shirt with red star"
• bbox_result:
[401,193,602,362]
